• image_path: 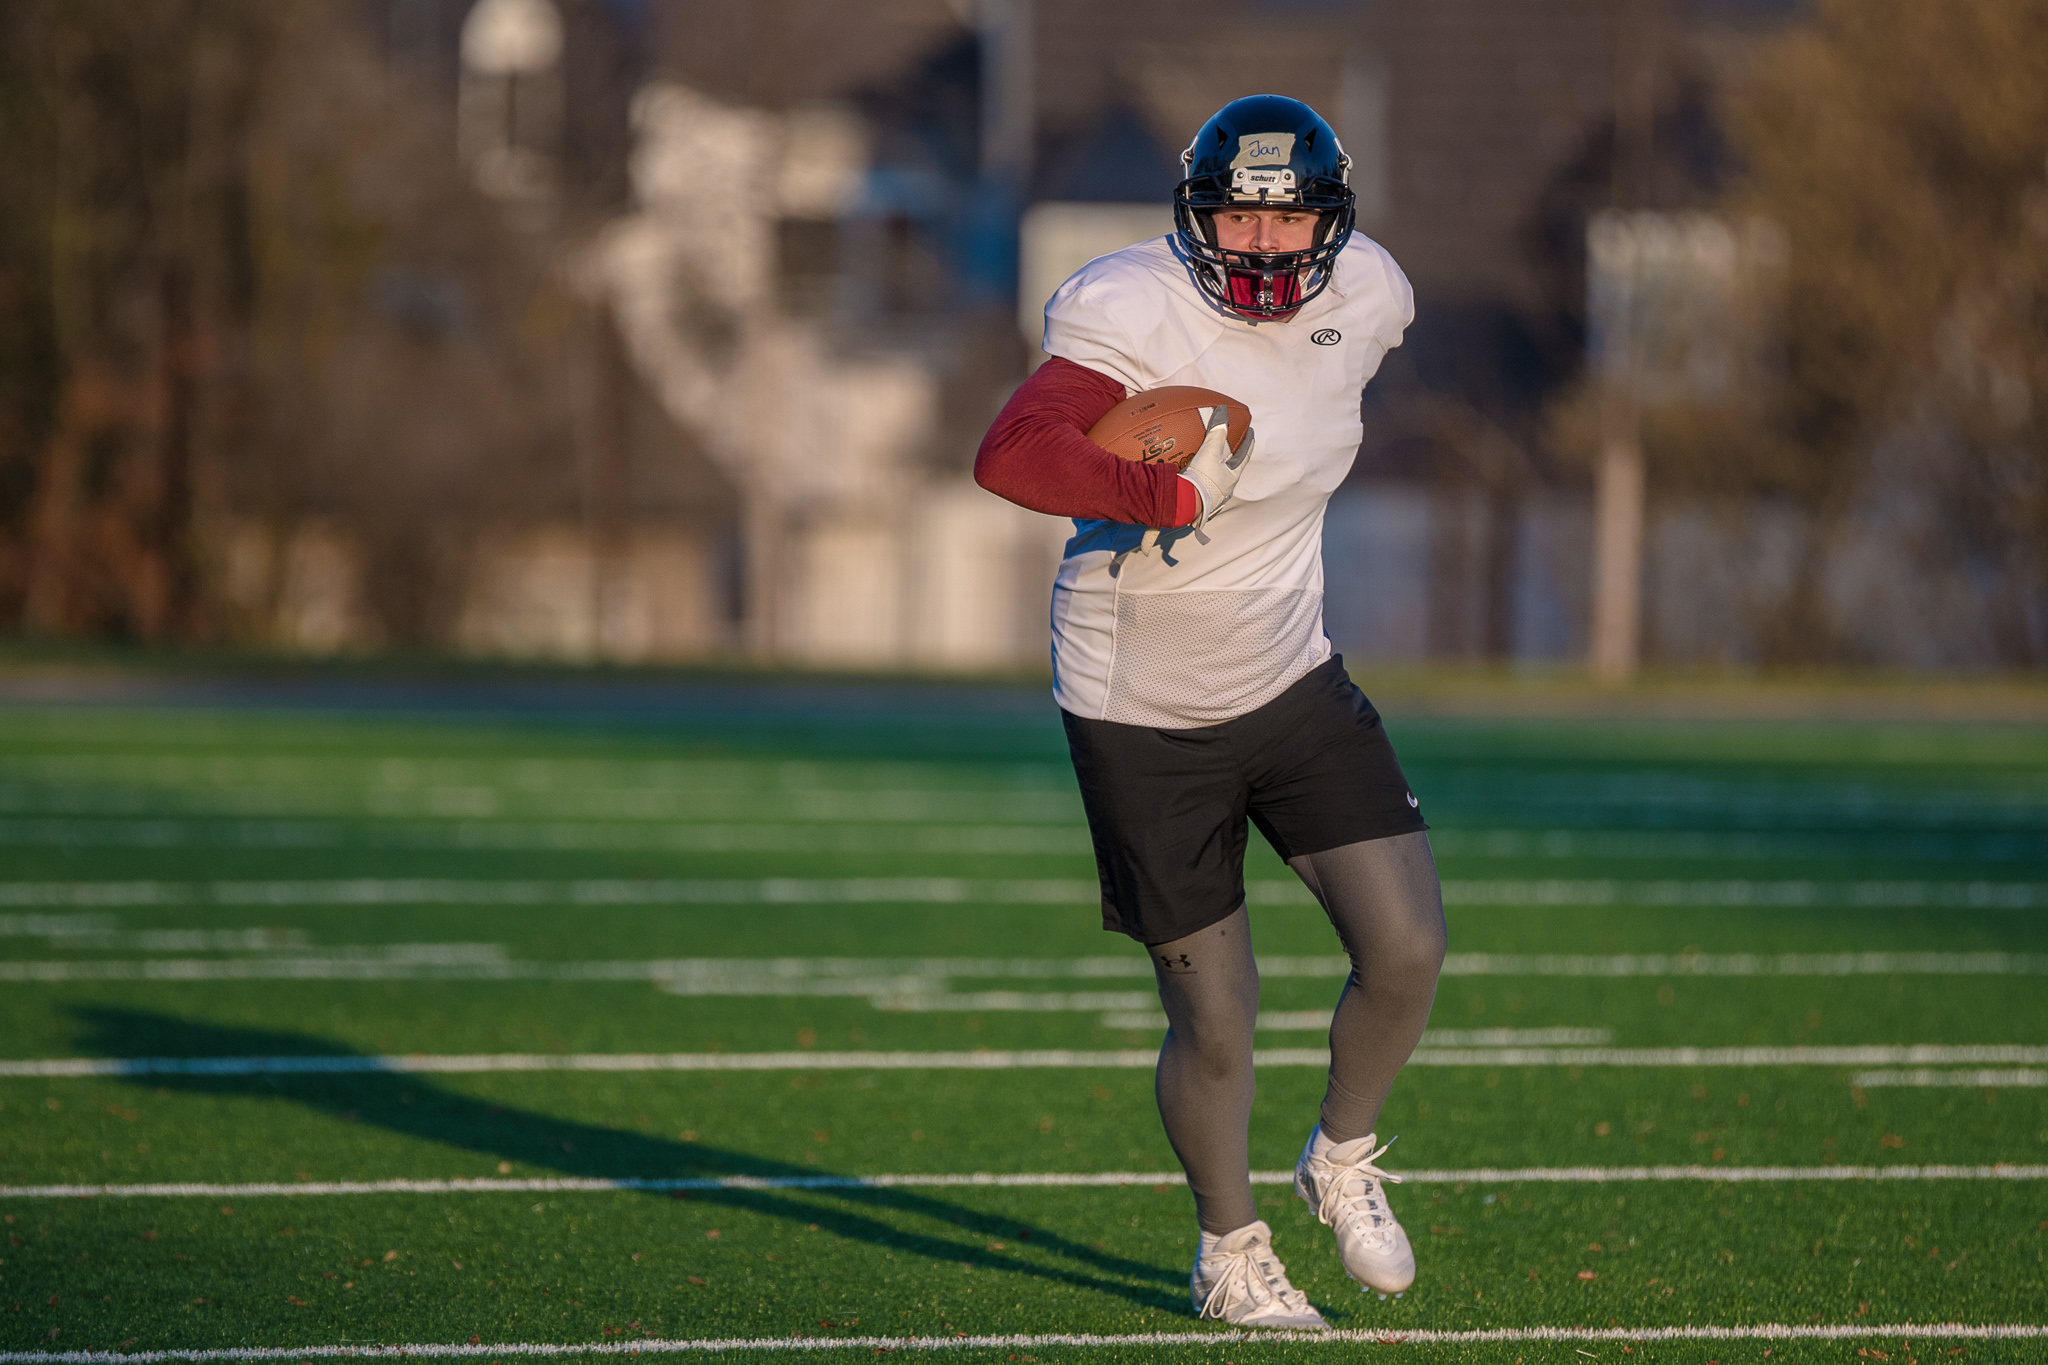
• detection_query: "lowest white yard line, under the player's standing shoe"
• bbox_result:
[0,1322,2048,1365]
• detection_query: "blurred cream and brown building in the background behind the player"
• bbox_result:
[344,0,1818,667]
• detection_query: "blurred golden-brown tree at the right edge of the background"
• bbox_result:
[1720,0,2048,665]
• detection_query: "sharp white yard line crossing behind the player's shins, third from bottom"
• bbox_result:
[0,1044,2048,1078]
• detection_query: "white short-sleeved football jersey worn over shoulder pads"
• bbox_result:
[1044,233,1415,731]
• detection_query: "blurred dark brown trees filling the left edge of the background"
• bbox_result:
[0,0,588,641]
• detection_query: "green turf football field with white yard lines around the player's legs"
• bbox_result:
[0,686,2048,1365]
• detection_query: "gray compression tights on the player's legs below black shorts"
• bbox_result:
[1151,833,1446,1234]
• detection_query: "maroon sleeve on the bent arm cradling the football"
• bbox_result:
[975,356,1200,526]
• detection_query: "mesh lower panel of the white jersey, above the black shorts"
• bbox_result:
[1102,587,1323,731]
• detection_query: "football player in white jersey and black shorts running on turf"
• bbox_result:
[975,94,1446,1328]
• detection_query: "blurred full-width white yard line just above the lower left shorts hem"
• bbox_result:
[0,878,2048,911]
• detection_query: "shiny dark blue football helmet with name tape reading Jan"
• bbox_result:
[1174,94,1358,319]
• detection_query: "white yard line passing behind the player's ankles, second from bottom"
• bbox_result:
[0,1162,2048,1199]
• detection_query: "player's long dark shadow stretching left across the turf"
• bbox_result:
[72,1009,1188,1312]
